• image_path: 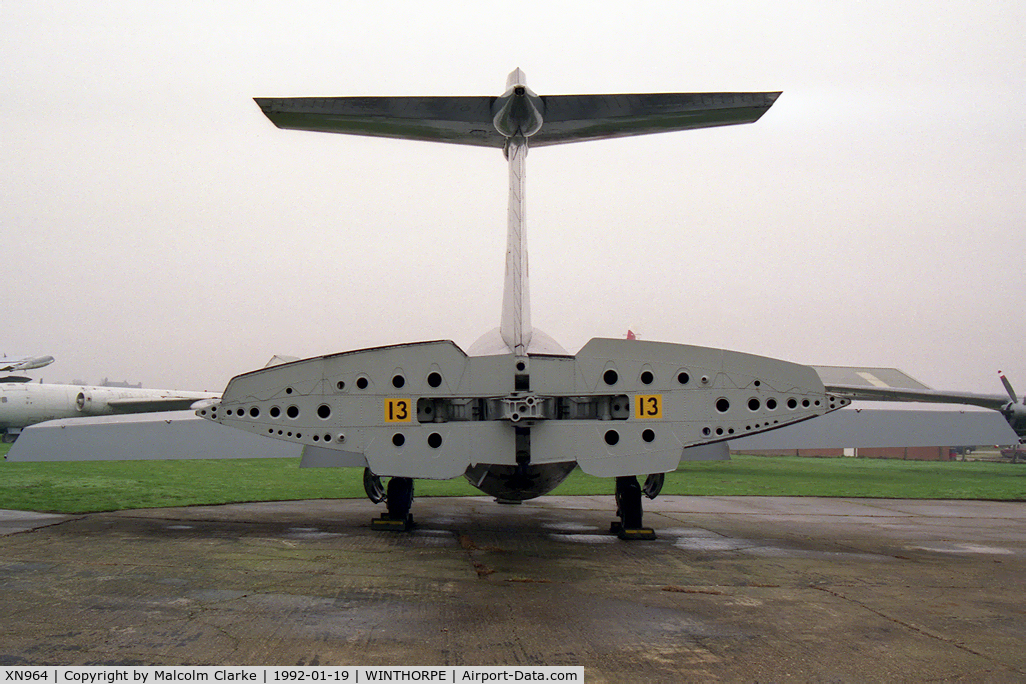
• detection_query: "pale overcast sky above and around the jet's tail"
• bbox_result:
[0,0,1026,393]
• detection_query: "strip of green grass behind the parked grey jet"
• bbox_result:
[0,438,1026,513]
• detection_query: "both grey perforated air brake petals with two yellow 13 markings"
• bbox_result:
[197,339,849,479]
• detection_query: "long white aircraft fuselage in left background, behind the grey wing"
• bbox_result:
[0,383,218,442]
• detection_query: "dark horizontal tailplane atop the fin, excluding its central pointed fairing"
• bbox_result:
[255,92,780,148]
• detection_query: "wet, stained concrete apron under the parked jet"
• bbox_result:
[0,496,1026,682]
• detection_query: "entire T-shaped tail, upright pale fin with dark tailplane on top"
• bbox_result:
[257,69,780,356]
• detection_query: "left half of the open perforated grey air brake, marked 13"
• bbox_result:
[198,340,516,479]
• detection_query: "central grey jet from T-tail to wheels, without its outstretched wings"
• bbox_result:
[197,69,850,538]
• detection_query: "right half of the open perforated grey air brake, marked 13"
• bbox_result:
[530,339,849,477]
